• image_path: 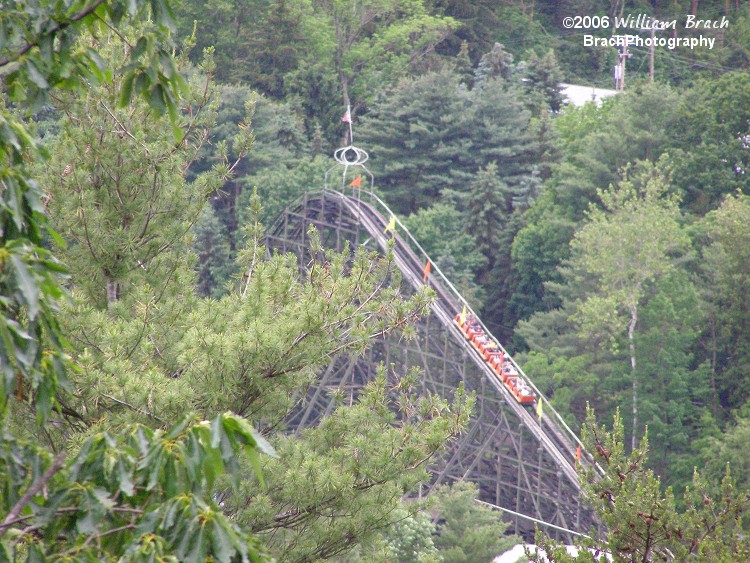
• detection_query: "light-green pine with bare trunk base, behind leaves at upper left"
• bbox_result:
[43,42,245,307]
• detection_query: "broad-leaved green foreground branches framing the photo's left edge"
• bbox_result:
[0,2,272,562]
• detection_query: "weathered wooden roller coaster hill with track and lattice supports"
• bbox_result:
[266,190,592,540]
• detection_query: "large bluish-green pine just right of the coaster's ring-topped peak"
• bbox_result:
[359,70,534,214]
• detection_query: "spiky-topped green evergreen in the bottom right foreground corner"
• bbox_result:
[527,411,750,563]
